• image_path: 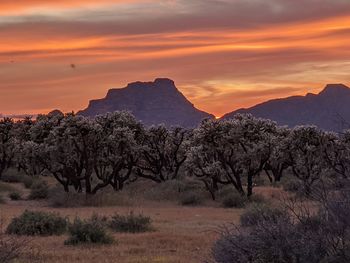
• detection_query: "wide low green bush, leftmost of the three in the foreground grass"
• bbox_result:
[6,210,67,236]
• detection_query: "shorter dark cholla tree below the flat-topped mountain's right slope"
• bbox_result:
[137,125,190,183]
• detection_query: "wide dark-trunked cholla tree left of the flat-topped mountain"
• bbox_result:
[32,114,102,194]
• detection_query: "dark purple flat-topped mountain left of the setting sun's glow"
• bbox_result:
[78,78,214,127]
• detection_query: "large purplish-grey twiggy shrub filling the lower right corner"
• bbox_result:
[212,190,350,263]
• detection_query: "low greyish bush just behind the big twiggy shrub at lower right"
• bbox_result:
[240,204,287,227]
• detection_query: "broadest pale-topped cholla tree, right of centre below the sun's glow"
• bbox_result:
[187,114,276,199]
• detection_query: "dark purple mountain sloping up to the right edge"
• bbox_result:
[222,84,350,131]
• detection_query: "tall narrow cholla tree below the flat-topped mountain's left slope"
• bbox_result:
[92,112,144,193]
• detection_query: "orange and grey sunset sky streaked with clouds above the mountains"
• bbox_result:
[0,0,350,116]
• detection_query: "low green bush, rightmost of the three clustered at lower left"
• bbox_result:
[109,212,152,233]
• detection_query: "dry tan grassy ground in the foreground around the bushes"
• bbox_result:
[0,183,284,263]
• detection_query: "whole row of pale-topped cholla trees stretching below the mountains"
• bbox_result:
[0,111,350,199]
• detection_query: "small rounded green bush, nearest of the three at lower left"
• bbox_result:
[64,216,114,245]
